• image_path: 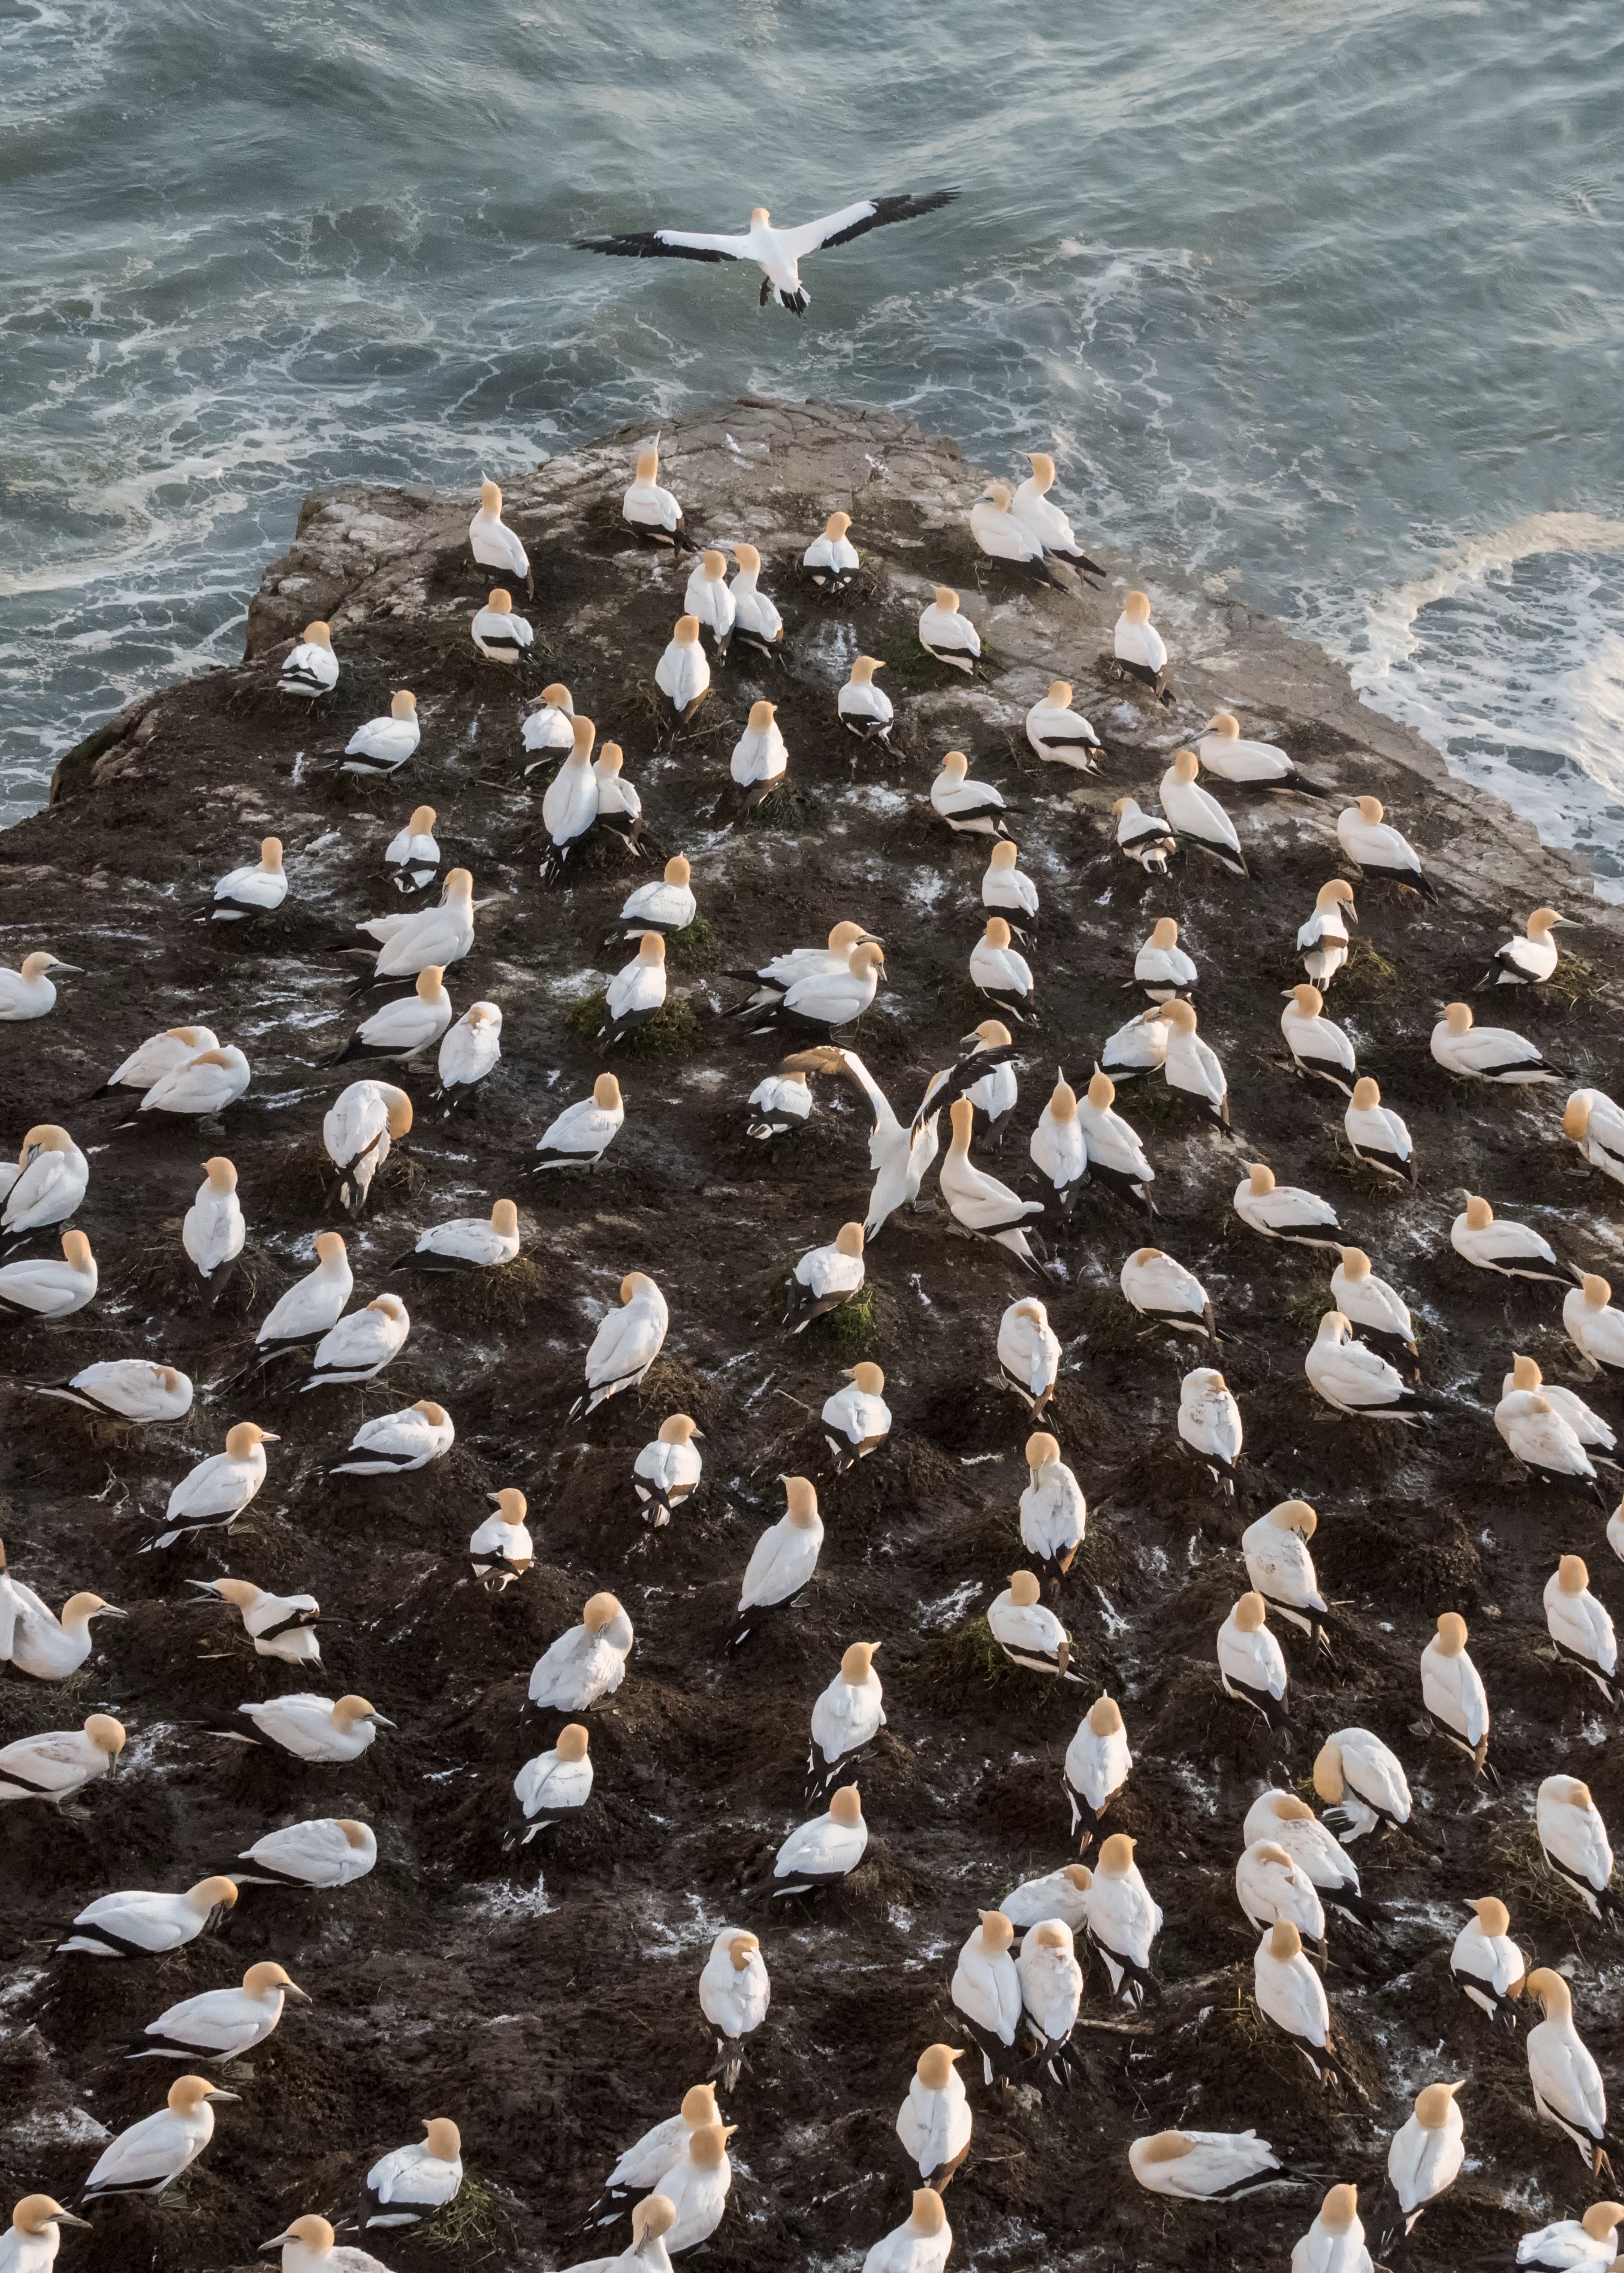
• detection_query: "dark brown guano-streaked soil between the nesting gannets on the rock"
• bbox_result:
[0,400,1624,2273]
